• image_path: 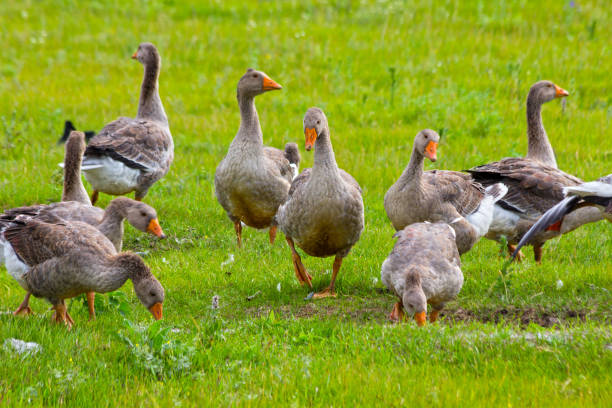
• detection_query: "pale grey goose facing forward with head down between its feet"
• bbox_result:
[380,222,463,326]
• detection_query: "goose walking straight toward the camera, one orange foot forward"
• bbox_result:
[276,108,364,298]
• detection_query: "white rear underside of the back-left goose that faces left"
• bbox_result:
[81,157,141,195]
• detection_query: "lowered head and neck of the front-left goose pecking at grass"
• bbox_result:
[116,252,165,320]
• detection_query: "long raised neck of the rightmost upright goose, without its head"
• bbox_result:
[527,95,557,168]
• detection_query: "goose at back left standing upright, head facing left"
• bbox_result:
[83,43,174,204]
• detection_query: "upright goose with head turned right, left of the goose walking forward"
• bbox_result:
[215,68,300,247]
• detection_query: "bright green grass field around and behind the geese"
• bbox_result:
[0,0,612,407]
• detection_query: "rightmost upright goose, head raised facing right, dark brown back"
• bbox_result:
[468,81,602,263]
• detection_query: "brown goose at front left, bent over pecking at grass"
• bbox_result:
[0,216,164,329]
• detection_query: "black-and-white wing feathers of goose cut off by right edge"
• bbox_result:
[512,174,612,258]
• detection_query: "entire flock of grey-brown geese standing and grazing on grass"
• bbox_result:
[0,43,612,328]
